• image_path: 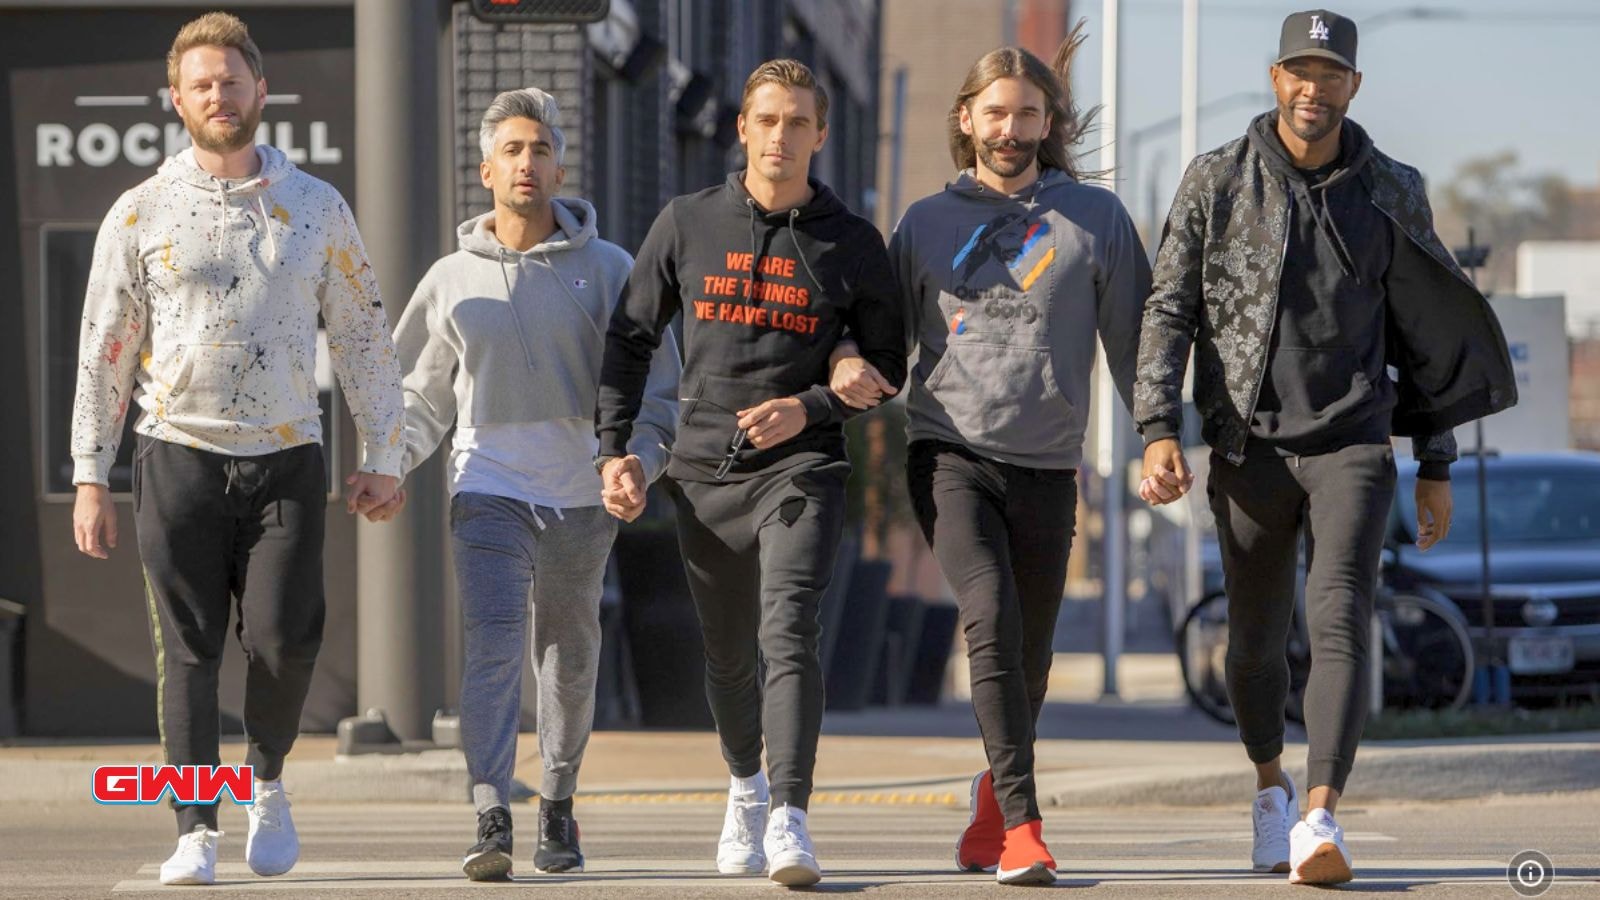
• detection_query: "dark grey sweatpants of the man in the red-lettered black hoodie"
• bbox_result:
[666,461,850,809]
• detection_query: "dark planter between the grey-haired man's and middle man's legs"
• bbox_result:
[616,522,712,729]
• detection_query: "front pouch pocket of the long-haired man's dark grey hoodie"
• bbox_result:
[925,341,1083,453]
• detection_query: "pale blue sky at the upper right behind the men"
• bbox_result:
[1072,0,1600,230]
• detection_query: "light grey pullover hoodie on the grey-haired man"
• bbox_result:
[395,197,682,506]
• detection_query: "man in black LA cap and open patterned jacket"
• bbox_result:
[1134,10,1517,884]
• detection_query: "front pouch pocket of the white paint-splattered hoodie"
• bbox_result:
[160,338,318,428]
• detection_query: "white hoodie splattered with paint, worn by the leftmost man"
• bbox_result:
[72,146,405,484]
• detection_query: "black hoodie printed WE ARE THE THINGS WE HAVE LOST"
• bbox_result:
[595,171,906,482]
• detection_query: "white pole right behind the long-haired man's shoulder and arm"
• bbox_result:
[1094,0,1128,700]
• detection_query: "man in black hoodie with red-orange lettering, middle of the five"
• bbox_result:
[595,59,906,886]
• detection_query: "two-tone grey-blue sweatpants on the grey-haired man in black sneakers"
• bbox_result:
[450,493,616,814]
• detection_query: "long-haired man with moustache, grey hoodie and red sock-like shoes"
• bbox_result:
[834,26,1150,884]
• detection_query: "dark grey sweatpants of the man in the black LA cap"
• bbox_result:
[1206,444,1395,793]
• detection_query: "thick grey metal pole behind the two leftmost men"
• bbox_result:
[355,0,450,741]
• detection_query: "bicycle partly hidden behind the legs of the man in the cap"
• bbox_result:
[1174,560,1477,725]
